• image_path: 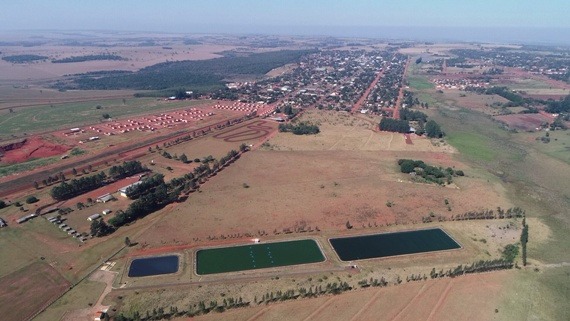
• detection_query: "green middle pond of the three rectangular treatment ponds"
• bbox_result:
[196,240,325,275]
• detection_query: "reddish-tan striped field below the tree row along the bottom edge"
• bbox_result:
[189,272,512,321]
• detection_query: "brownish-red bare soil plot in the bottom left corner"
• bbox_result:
[0,262,71,320]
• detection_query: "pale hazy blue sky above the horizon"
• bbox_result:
[0,0,570,43]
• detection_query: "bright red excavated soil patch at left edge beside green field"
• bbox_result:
[2,136,70,163]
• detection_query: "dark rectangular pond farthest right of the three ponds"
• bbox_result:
[330,228,461,261]
